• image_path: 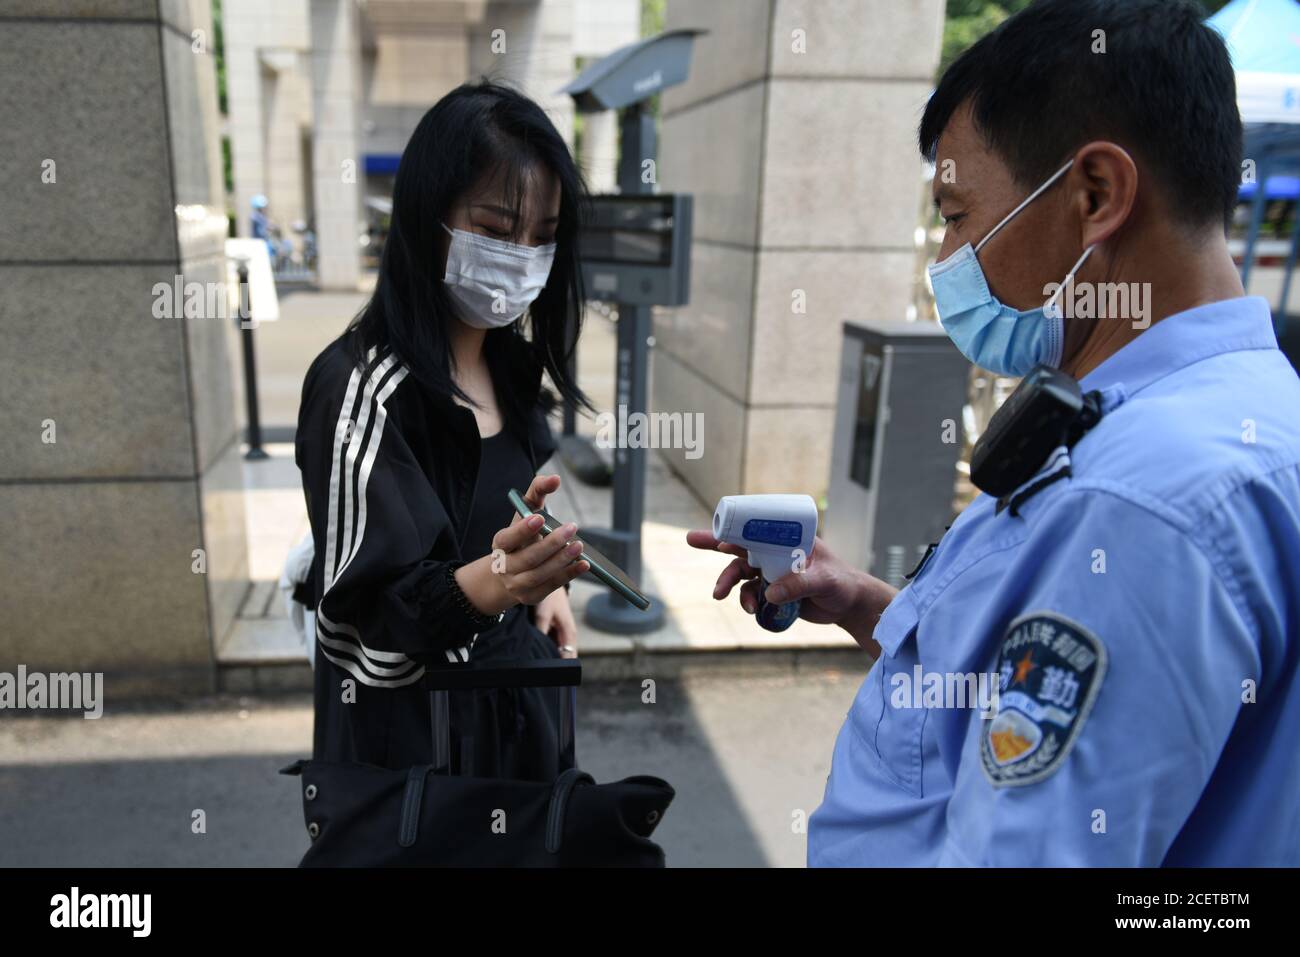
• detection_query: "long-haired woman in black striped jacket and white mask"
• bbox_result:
[296,82,590,779]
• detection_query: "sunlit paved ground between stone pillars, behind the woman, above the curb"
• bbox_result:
[218,291,857,676]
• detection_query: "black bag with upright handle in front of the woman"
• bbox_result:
[282,659,673,867]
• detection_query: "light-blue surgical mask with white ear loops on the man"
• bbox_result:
[930,160,1095,376]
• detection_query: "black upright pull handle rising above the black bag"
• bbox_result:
[424,658,582,775]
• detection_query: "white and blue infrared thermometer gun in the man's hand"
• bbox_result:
[714,495,816,632]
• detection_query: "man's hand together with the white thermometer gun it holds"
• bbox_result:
[686,495,897,655]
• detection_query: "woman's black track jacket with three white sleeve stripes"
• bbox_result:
[296,333,555,767]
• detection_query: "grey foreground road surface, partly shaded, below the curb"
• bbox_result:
[0,659,865,867]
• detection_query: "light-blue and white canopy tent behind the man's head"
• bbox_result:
[1206,0,1300,339]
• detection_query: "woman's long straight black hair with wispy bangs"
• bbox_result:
[346,79,593,432]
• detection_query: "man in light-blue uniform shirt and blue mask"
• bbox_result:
[688,0,1300,866]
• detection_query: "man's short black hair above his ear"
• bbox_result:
[920,0,1242,226]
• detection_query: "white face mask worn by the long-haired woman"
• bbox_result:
[442,224,555,329]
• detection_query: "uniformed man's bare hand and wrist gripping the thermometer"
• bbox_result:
[686,529,898,657]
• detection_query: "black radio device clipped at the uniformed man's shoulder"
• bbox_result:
[971,365,1101,498]
